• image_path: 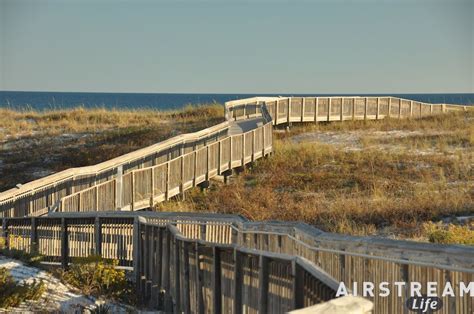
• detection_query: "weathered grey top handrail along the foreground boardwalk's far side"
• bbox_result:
[0,211,474,273]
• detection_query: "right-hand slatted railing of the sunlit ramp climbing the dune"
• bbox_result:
[58,123,272,212]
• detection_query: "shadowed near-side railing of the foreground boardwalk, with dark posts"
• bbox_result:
[2,213,338,313]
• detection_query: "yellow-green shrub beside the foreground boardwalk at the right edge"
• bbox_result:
[423,222,474,245]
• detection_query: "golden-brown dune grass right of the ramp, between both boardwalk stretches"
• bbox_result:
[157,112,474,244]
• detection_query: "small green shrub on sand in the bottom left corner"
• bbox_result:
[0,268,46,308]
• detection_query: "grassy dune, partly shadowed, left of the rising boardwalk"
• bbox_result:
[0,103,224,191]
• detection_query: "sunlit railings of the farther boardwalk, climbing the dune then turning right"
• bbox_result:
[0,97,470,217]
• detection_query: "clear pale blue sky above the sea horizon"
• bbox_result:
[0,0,474,94]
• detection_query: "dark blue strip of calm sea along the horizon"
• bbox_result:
[0,91,474,110]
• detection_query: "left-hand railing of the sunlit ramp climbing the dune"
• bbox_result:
[0,122,229,217]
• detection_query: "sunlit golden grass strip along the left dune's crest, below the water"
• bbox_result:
[0,103,224,140]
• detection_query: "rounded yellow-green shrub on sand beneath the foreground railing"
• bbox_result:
[59,255,136,304]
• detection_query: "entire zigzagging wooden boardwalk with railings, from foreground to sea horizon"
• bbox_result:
[0,97,474,313]
